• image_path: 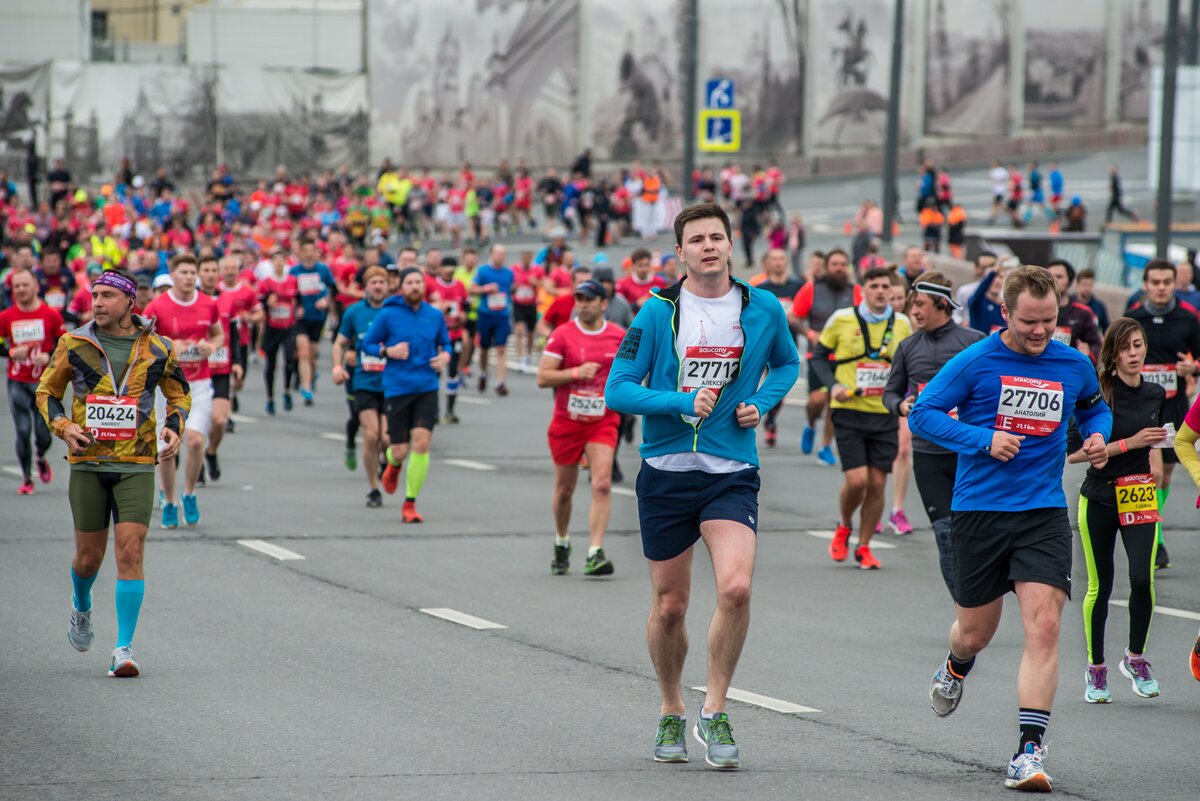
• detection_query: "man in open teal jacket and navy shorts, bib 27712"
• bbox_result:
[605,203,800,770]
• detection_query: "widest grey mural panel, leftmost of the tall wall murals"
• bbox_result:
[367,0,578,167]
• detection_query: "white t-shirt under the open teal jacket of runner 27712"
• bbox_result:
[646,287,754,472]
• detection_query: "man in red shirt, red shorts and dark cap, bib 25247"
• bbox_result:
[538,281,625,576]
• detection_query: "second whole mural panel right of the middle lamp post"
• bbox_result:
[1021,0,1106,128]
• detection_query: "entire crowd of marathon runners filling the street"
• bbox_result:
[0,159,1200,790]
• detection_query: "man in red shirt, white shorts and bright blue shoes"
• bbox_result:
[144,253,226,529]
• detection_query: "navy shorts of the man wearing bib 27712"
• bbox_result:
[637,460,761,561]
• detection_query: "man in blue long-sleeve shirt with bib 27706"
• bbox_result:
[908,266,1112,791]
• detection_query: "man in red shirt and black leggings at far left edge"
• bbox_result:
[0,271,66,495]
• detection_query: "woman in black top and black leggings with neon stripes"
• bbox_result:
[1068,317,1166,704]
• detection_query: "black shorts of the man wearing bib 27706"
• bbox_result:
[953,508,1072,607]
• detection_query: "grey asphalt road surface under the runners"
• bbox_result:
[0,326,1200,801]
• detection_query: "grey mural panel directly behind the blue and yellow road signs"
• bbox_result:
[700,0,808,153]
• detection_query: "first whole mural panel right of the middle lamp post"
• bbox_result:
[925,0,1014,137]
